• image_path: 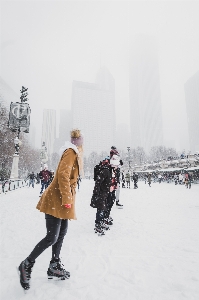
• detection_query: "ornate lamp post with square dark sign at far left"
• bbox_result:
[8,86,31,179]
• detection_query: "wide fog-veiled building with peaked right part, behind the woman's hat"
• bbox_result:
[72,67,115,156]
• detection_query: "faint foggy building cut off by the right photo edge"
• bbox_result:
[184,71,199,153]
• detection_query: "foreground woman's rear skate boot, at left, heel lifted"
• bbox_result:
[18,258,35,290]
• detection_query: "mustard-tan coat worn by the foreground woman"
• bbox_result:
[36,148,79,220]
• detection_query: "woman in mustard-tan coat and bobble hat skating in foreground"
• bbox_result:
[18,129,83,290]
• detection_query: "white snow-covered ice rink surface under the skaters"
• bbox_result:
[0,179,199,300]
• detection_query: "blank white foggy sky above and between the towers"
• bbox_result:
[1,0,199,150]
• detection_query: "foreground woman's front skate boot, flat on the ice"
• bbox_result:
[47,259,70,280]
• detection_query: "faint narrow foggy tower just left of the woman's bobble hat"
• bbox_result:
[54,109,72,153]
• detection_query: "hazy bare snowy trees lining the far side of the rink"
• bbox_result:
[0,104,178,179]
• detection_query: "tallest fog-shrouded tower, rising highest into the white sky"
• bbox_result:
[129,35,163,152]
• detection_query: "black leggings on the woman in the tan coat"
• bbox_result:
[28,214,68,261]
